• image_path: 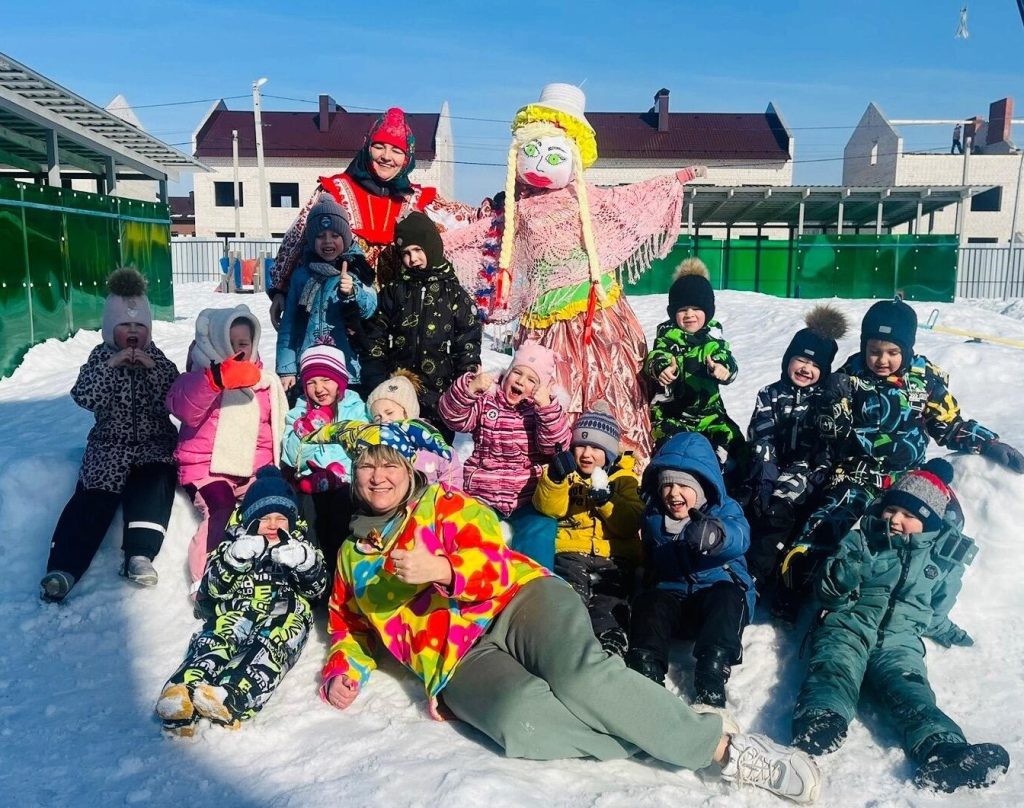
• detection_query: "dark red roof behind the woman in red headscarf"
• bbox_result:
[195,109,440,160]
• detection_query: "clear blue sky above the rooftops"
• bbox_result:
[0,0,1024,202]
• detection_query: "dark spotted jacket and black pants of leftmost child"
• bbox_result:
[46,342,178,581]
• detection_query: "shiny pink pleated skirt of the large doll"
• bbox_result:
[514,295,651,466]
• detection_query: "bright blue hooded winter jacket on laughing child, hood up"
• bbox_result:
[641,432,757,613]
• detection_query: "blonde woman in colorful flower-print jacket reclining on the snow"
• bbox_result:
[321,424,820,802]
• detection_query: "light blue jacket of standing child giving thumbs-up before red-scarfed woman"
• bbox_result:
[275,246,377,384]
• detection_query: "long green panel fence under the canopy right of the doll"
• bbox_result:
[626,235,957,302]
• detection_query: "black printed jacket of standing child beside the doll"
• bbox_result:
[362,261,482,425]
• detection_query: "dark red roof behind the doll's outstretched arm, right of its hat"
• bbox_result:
[587,112,790,161]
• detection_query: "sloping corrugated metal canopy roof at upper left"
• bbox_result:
[0,53,208,180]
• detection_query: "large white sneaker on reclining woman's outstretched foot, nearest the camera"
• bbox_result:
[722,734,821,803]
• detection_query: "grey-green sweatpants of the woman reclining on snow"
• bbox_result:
[442,578,722,769]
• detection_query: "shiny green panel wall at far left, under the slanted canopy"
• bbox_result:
[0,179,174,376]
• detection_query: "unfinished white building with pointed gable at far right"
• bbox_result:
[843,98,1024,244]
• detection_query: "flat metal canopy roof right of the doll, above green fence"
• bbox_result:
[683,184,993,227]
